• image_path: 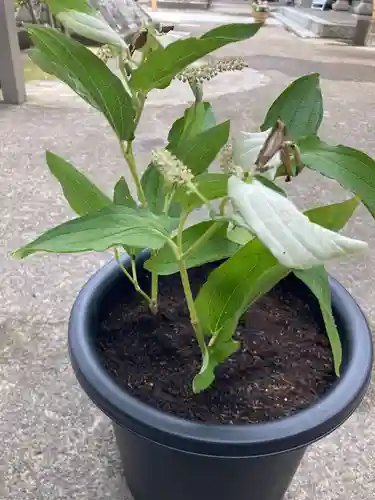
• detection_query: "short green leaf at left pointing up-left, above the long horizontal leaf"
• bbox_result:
[46,151,112,215]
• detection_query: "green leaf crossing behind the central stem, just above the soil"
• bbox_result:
[145,221,238,275]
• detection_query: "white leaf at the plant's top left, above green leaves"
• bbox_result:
[57,10,126,48]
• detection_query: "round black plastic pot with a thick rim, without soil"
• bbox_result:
[69,254,372,500]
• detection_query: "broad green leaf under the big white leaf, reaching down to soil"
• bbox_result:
[193,239,289,392]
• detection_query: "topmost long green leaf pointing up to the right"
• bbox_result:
[131,23,260,92]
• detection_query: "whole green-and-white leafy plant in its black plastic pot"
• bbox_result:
[15,1,375,500]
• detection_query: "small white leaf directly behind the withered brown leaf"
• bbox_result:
[233,129,282,180]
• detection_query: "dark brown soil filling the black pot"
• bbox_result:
[97,268,335,424]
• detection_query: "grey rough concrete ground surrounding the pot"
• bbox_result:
[0,15,375,500]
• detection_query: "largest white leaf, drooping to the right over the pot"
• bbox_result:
[228,176,368,269]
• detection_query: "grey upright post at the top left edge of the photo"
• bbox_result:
[0,0,25,104]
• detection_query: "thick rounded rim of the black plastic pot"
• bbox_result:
[69,257,373,457]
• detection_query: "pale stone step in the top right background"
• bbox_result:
[275,7,357,40]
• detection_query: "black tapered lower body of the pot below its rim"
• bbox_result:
[114,424,305,500]
